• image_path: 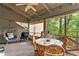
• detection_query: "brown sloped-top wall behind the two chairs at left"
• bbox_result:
[0,4,27,39]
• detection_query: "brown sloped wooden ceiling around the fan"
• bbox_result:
[2,3,79,20]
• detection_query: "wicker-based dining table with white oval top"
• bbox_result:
[36,38,63,56]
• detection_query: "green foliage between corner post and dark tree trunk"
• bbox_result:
[46,17,59,34]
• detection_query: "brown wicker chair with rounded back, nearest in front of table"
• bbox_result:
[44,45,65,56]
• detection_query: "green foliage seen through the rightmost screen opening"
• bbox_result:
[67,15,79,37]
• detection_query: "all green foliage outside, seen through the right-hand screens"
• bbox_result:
[46,14,79,37]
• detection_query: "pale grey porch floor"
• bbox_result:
[2,41,72,56]
